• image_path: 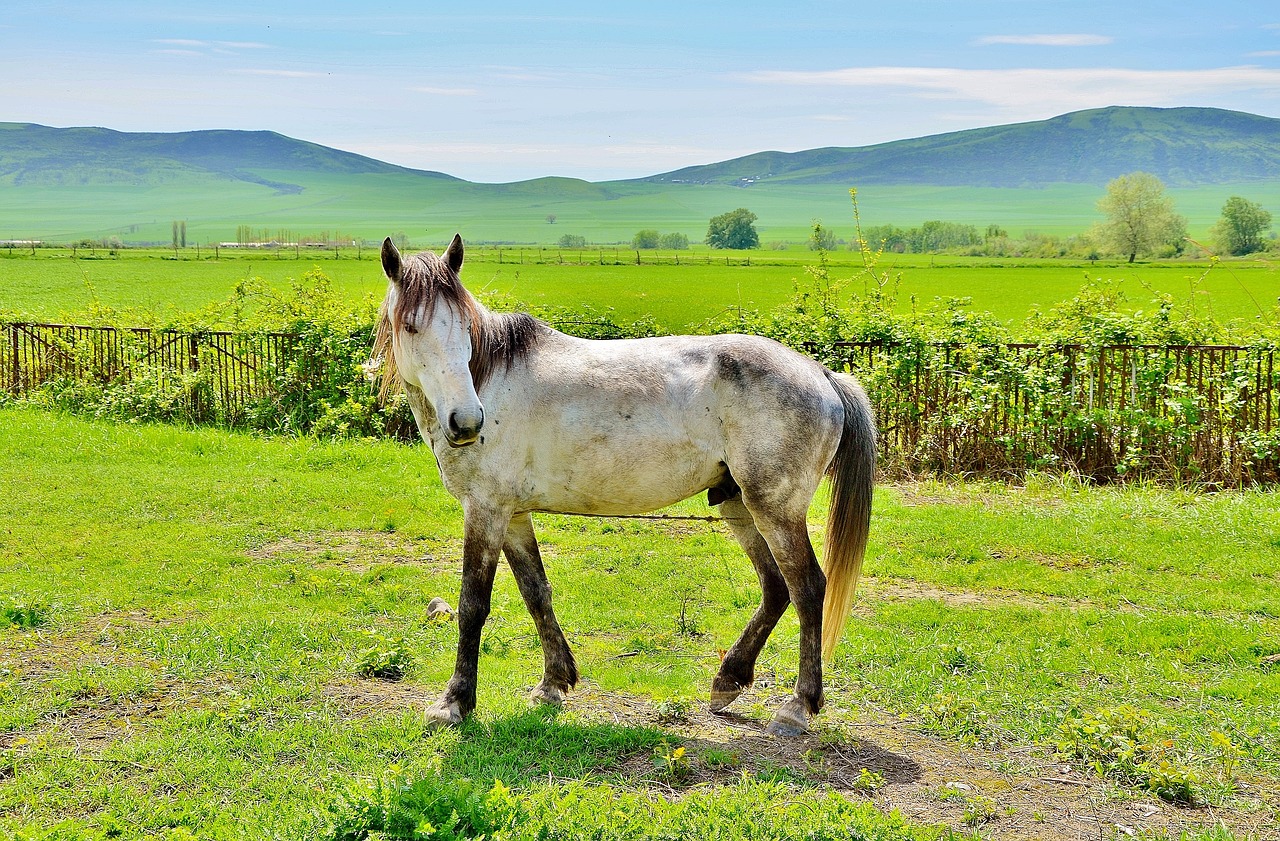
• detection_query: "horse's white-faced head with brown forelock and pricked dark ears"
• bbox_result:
[378,236,484,447]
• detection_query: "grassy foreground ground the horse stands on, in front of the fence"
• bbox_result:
[0,407,1280,840]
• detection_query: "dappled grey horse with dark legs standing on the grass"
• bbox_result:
[370,236,876,736]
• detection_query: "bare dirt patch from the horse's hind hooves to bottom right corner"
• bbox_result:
[566,685,1280,841]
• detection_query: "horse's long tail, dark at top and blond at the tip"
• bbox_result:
[822,372,876,661]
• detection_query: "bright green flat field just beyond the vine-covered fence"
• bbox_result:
[0,246,1280,332]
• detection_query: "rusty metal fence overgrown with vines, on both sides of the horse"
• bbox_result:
[0,323,1280,485]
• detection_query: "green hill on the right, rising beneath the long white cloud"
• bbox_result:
[641,108,1280,187]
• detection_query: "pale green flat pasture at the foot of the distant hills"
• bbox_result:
[0,170,1276,244]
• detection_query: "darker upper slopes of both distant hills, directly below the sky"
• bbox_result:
[0,106,1280,193]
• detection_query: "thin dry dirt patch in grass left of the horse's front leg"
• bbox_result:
[248,530,462,572]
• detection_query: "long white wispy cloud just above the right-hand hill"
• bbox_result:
[746,65,1280,111]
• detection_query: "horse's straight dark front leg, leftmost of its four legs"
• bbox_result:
[426,502,511,725]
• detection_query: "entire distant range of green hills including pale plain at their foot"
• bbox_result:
[0,108,1280,243]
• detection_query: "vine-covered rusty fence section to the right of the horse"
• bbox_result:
[809,342,1280,485]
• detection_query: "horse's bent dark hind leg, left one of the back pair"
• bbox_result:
[710,497,791,713]
